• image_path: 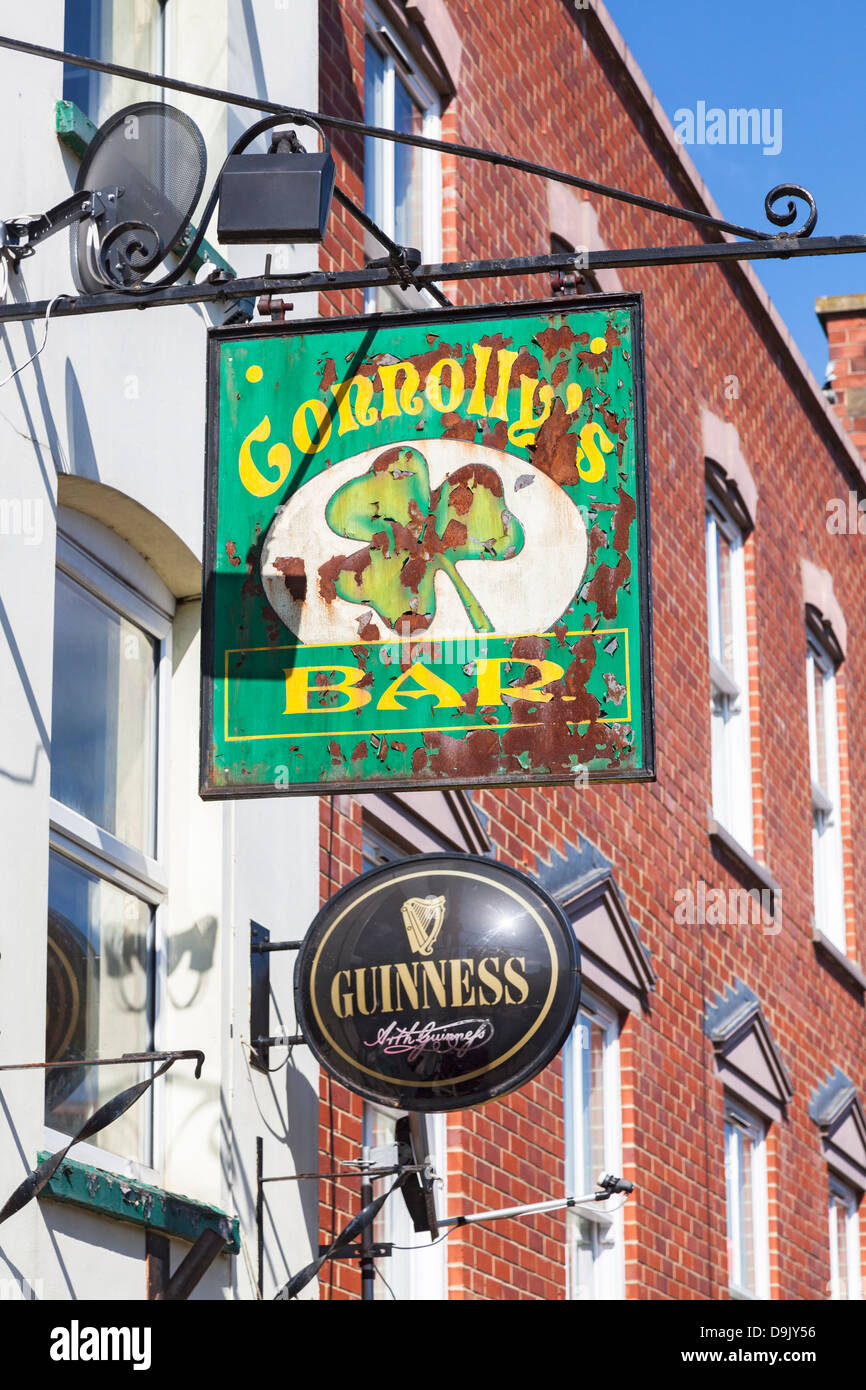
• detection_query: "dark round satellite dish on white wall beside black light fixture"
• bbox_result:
[71,101,207,295]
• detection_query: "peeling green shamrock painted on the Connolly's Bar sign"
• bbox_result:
[320,445,524,632]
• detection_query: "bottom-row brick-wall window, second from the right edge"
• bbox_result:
[724,1104,770,1298]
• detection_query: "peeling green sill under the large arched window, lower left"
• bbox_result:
[38,1152,240,1255]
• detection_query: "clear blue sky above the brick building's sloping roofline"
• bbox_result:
[606,0,866,384]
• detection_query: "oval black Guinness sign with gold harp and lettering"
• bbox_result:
[295,855,580,1111]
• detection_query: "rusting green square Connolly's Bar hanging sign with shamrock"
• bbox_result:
[202,295,655,796]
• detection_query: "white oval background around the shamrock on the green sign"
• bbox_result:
[261,436,587,644]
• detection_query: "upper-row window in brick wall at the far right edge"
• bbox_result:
[806,630,845,952]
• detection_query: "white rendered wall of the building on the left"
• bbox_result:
[0,0,318,1298]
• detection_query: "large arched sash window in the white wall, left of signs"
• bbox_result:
[46,509,172,1169]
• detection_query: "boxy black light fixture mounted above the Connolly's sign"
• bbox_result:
[217,121,336,246]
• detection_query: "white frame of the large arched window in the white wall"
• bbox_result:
[44,507,174,1184]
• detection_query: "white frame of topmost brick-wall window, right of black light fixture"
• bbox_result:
[364,0,442,313]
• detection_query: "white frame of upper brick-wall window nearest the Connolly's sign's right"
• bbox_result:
[705,488,753,855]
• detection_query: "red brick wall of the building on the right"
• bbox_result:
[320,0,866,1300]
